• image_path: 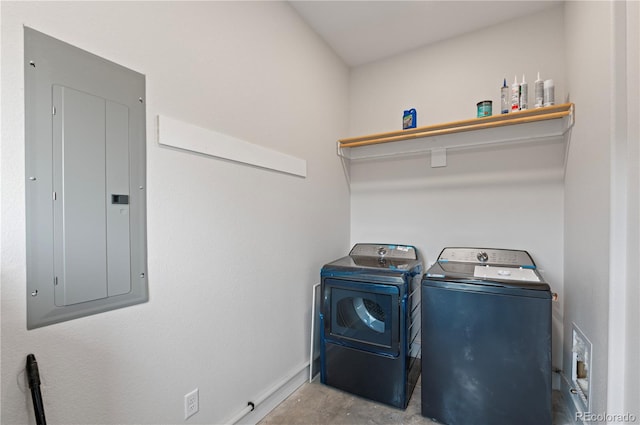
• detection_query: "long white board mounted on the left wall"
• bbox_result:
[158,115,307,177]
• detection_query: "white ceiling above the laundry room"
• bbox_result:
[290,0,562,67]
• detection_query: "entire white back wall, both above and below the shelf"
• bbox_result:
[344,6,564,387]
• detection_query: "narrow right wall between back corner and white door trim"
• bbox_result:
[564,2,617,413]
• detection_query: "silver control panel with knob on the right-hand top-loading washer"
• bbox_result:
[438,248,535,268]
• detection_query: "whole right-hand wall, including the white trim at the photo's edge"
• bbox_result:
[564,1,640,422]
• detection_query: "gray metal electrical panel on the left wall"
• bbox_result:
[25,28,148,329]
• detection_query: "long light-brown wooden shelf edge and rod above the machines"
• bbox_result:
[338,103,574,148]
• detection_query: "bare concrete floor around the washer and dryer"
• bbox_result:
[258,378,574,425]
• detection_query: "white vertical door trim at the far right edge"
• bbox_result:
[607,2,640,417]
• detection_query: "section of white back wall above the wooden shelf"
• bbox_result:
[349,7,566,136]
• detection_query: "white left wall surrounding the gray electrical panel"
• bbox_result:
[0,1,349,424]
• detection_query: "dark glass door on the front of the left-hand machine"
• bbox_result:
[323,279,400,355]
